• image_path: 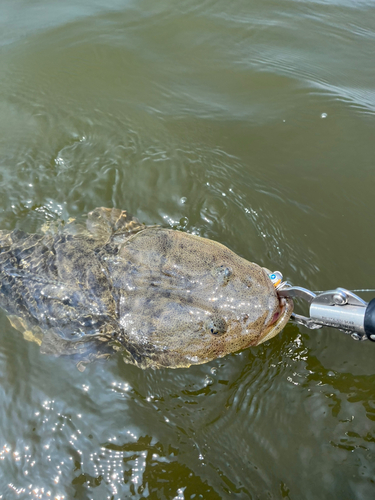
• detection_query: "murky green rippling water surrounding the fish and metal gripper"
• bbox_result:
[0,0,375,500]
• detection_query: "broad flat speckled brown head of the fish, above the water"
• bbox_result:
[117,228,293,367]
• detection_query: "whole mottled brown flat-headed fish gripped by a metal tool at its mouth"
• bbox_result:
[0,208,293,368]
